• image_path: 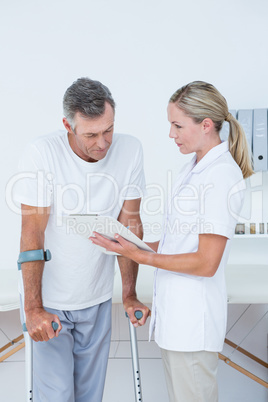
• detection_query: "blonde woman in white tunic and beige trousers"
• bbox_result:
[91,81,253,402]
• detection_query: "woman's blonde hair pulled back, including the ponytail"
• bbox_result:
[169,81,254,178]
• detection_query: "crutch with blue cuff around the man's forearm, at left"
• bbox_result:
[17,249,58,402]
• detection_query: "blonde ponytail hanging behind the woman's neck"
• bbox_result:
[225,113,254,179]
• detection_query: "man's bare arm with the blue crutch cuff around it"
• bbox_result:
[20,204,61,342]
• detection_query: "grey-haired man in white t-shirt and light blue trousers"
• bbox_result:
[14,78,149,402]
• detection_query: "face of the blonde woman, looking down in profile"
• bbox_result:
[167,103,204,155]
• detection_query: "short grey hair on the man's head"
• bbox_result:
[63,77,115,127]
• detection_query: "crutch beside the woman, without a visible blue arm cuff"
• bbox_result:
[126,310,143,402]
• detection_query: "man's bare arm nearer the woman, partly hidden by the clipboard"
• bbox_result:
[118,198,150,326]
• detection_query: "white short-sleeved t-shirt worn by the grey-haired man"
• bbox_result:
[14,131,145,310]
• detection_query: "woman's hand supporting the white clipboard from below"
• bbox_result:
[89,232,142,263]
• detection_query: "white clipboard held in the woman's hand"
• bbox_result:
[63,214,155,255]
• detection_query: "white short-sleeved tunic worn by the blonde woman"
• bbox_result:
[150,142,245,352]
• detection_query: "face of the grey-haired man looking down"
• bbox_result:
[63,102,114,162]
